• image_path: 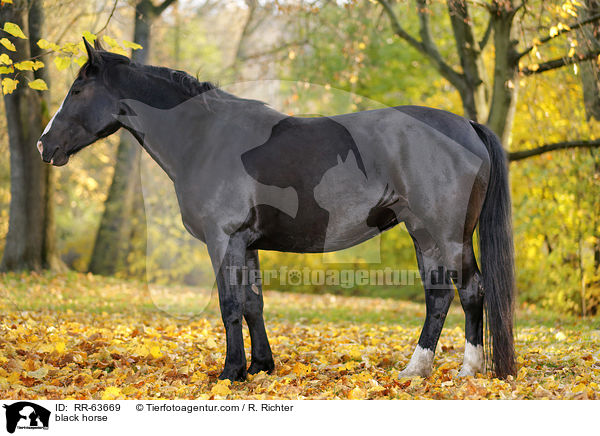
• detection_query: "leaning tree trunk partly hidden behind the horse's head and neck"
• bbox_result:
[89,0,157,277]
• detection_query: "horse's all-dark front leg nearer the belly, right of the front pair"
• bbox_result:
[244,250,275,374]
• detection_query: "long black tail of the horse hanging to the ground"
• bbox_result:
[471,122,516,378]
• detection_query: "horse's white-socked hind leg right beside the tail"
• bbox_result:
[458,244,485,377]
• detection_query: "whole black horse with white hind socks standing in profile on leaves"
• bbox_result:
[38,41,515,380]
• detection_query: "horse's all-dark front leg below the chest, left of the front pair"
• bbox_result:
[209,230,246,381]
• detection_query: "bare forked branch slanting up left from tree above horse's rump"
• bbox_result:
[377,0,465,88]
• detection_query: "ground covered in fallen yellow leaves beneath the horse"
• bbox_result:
[0,274,600,399]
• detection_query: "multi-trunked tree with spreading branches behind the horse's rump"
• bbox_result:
[378,0,600,152]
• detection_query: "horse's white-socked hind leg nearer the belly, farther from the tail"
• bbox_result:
[399,234,454,378]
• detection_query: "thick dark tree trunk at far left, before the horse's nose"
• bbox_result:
[0,0,60,271]
